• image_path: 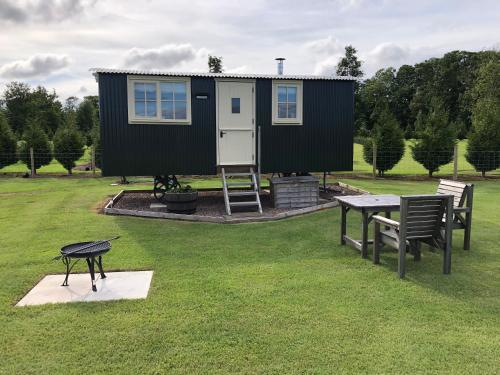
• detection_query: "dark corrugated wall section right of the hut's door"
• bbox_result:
[256,79,354,173]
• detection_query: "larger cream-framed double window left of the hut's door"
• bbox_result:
[127,76,191,125]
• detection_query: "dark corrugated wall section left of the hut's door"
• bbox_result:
[99,73,216,176]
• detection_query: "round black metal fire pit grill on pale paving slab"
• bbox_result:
[61,240,111,292]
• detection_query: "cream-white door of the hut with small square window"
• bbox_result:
[217,81,255,165]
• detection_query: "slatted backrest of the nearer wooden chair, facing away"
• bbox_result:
[401,195,452,240]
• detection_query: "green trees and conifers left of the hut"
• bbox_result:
[0,82,100,174]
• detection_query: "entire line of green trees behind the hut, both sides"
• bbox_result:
[0,50,500,176]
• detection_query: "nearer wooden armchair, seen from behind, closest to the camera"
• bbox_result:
[372,194,453,278]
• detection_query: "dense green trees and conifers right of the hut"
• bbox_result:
[337,46,500,176]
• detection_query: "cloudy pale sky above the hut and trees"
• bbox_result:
[0,0,500,100]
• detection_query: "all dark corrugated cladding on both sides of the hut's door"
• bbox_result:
[99,73,354,176]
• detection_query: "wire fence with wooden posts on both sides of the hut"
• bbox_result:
[0,142,500,179]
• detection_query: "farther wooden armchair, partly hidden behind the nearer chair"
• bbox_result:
[437,180,474,250]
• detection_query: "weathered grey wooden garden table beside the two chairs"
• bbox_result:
[337,195,400,258]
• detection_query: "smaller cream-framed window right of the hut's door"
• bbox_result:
[272,80,302,125]
